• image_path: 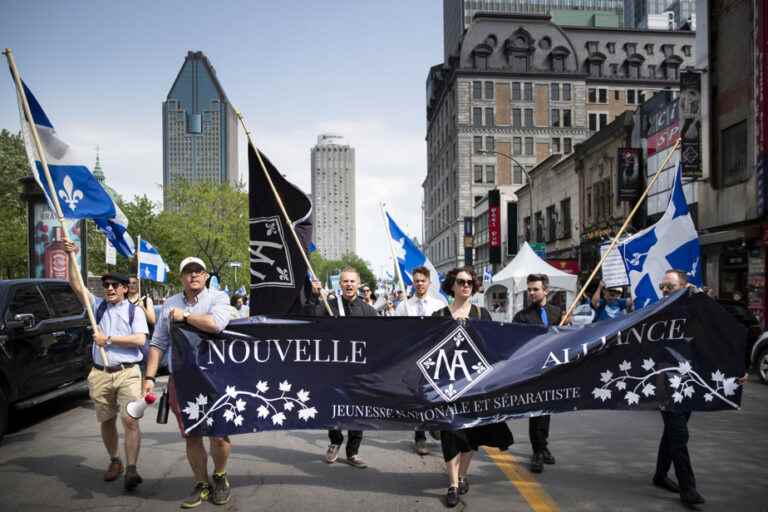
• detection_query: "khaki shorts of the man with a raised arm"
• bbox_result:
[88,365,142,423]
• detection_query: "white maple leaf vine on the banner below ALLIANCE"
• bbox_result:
[592,358,740,409]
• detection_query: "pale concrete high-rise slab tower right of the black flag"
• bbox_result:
[312,134,356,260]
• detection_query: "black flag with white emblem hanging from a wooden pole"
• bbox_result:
[248,144,312,316]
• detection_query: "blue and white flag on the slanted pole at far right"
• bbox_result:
[618,164,702,308]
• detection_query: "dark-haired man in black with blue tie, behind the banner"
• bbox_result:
[514,274,563,473]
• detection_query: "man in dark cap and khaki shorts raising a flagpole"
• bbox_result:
[64,241,149,491]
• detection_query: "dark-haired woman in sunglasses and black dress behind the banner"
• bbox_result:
[432,267,514,507]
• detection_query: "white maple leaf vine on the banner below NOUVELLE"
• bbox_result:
[182,380,317,433]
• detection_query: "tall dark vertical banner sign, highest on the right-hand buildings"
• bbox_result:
[680,71,702,178]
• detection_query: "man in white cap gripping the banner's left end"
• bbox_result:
[144,256,231,508]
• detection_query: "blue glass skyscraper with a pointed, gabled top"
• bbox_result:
[163,52,238,207]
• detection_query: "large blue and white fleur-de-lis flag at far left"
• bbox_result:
[17,83,134,257]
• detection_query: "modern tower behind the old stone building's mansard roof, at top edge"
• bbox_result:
[443,0,625,62]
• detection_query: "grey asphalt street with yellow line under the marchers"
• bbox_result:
[0,378,768,512]
